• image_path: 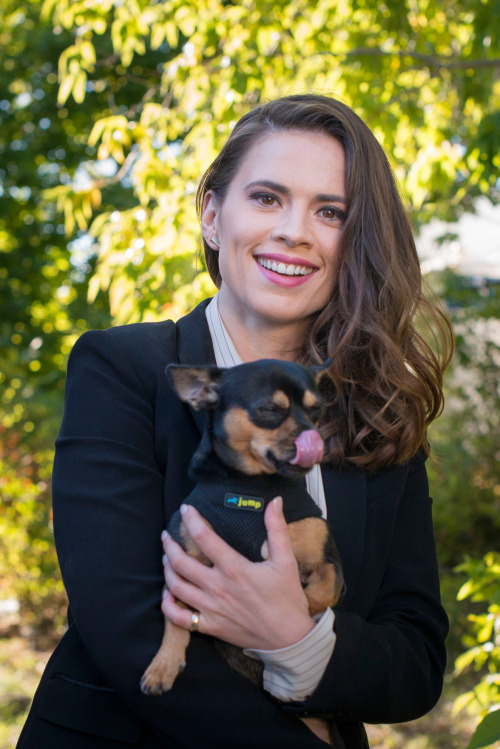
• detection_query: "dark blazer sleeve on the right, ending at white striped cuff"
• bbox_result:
[290,455,448,723]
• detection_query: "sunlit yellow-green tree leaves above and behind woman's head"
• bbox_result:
[38,0,500,322]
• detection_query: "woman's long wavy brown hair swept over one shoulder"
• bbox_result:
[197,94,453,471]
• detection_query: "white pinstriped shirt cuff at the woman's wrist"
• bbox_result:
[243,608,337,702]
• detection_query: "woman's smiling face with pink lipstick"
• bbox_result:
[202,130,345,332]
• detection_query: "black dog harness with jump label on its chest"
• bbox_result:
[168,475,321,562]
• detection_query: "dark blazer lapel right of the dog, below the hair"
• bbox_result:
[321,466,366,605]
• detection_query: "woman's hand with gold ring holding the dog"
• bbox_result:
[162,497,314,650]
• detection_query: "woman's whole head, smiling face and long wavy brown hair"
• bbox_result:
[198,95,451,470]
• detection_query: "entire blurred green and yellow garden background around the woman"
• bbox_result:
[0,0,500,749]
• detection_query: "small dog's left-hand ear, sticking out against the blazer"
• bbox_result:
[165,364,224,411]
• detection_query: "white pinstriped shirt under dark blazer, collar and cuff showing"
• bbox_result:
[206,294,336,701]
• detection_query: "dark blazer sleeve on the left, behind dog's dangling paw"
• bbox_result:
[53,323,332,749]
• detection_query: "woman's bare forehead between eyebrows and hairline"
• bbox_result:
[230,130,345,195]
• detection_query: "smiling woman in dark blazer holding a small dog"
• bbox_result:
[19,95,449,749]
